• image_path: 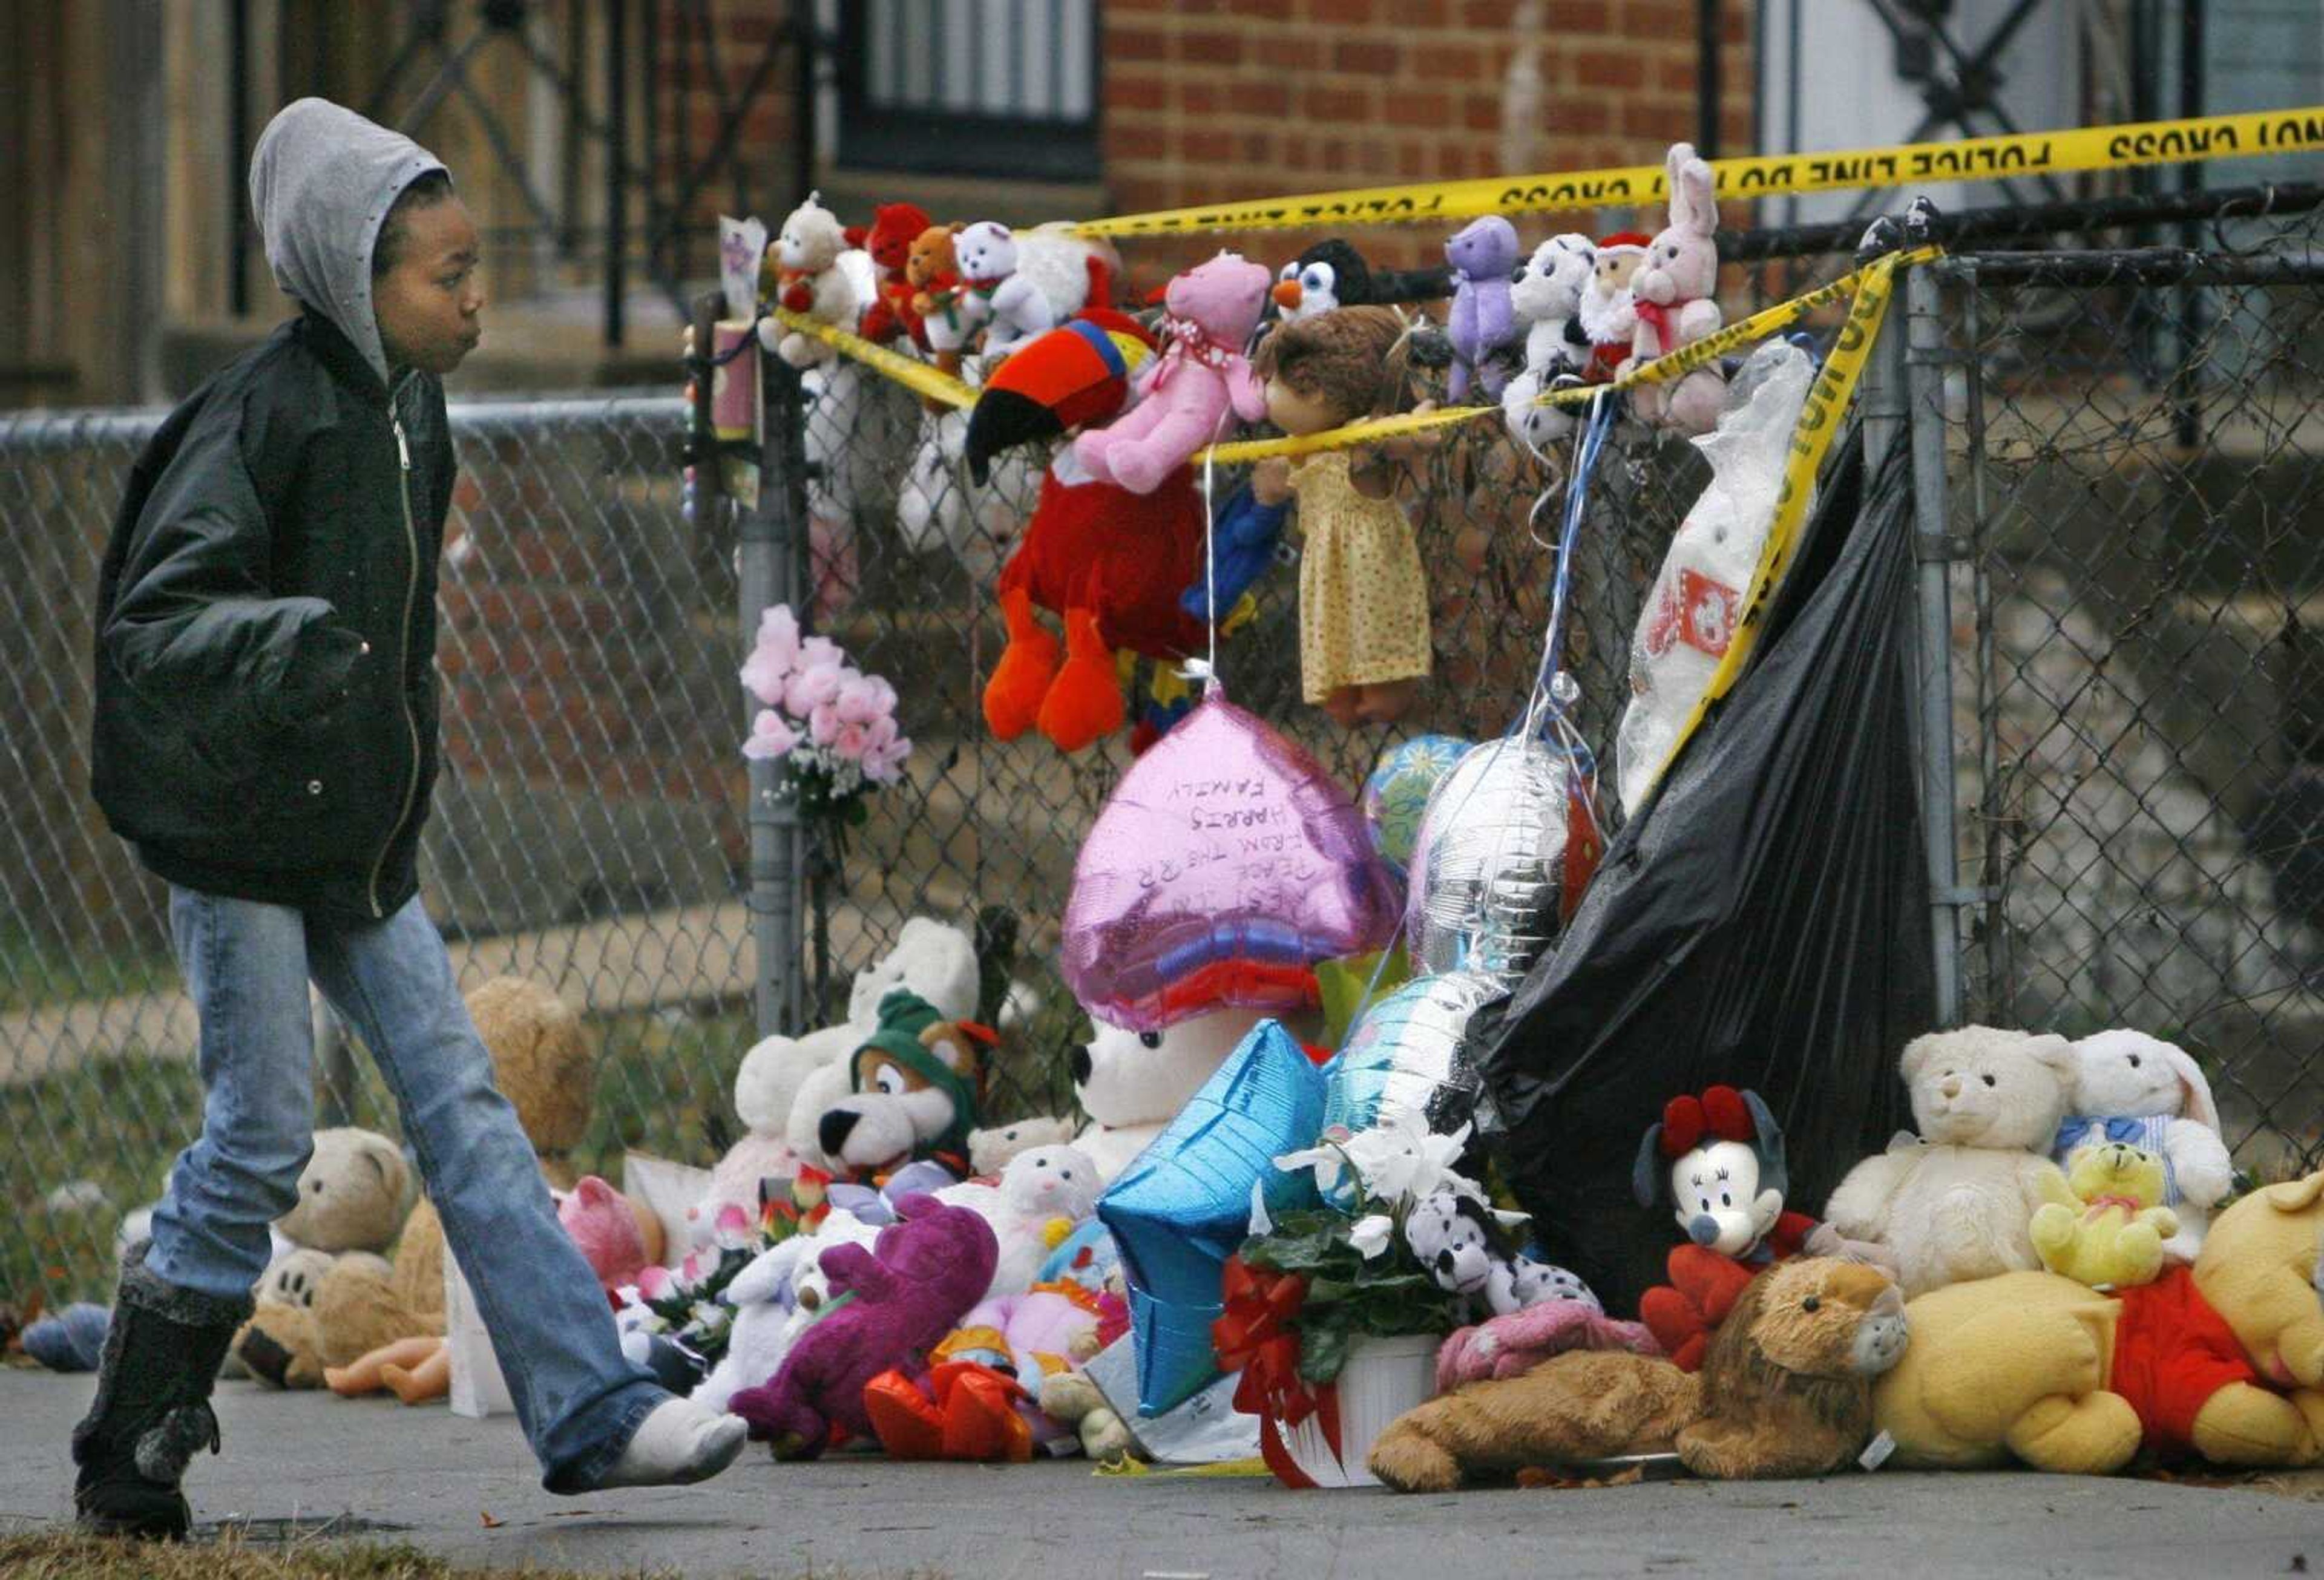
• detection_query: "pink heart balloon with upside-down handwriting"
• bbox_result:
[1065,690,1402,1032]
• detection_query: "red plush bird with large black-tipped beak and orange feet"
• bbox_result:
[965,309,1204,753]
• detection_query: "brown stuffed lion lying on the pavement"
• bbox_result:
[1371,1257,1906,1492]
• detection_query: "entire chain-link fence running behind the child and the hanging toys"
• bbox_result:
[0,185,2324,1301]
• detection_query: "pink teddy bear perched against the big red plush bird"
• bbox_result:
[1074,254,1273,495]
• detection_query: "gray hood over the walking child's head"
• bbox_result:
[251,97,448,384]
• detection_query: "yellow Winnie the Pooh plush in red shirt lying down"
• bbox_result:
[1873,1173,2324,1475]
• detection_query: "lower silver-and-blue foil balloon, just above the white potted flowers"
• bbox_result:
[1322,971,1502,1152]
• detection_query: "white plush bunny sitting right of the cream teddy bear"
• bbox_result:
[2050,1032,2236,1262]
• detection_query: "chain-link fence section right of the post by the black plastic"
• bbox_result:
[1912,193,2324,1176]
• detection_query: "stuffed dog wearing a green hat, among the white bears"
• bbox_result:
[816,988,995,1178]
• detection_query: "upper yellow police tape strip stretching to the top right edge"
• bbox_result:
[1071,105,2324,237]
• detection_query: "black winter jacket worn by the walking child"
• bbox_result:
[91,313,456,918]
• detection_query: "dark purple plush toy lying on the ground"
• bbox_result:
[727,1196,999,1459]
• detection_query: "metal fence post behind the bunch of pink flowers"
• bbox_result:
[737,353,806,1037]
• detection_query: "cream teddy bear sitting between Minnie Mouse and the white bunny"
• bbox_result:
[1824,1027,2075,1299]
